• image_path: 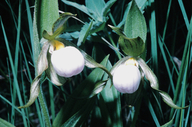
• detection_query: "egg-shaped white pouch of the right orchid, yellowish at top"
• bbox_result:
[113,58,141,93]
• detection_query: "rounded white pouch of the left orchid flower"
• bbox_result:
[51,46,85,77]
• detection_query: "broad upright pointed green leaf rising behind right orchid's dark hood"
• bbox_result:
[124,0,147,42]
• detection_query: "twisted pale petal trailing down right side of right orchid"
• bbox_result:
[137,58,188,109]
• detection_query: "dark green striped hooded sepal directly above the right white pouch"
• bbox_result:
[108,25,145,57]
